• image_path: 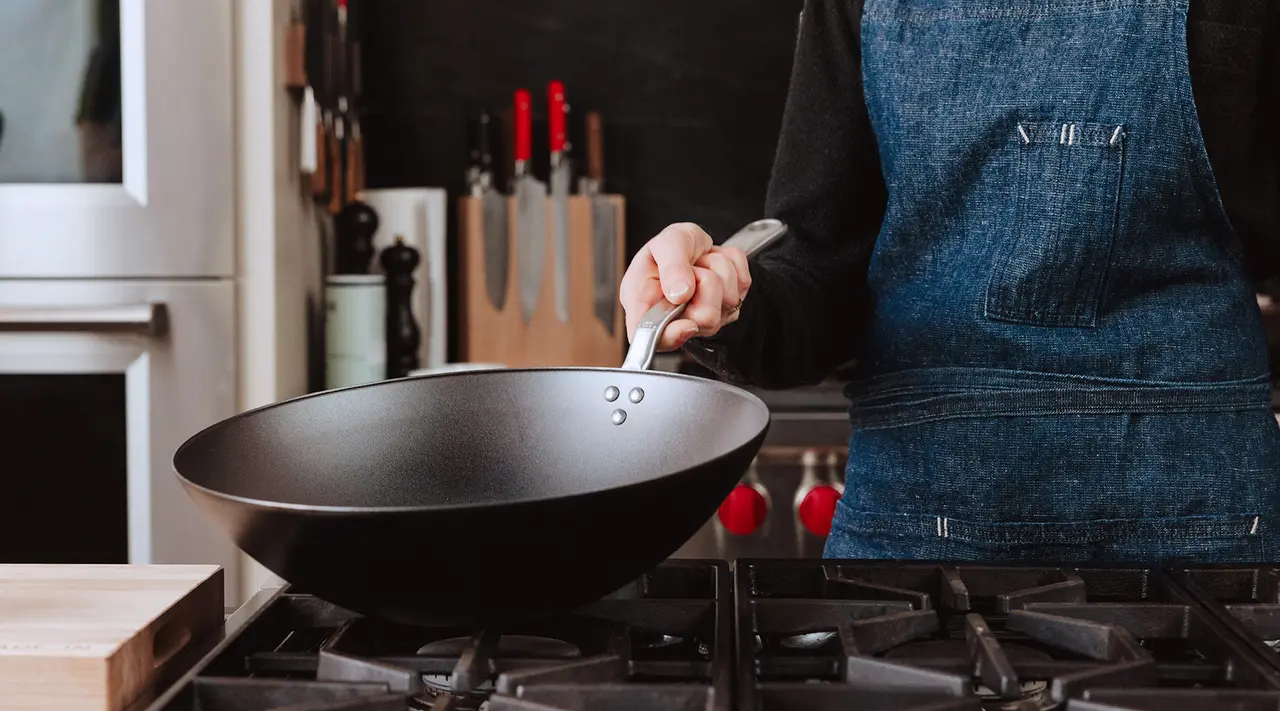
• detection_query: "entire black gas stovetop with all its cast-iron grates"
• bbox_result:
[137,560,1280,711]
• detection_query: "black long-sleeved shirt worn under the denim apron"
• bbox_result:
[686,0,1280,388]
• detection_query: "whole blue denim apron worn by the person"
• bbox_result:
[826,0,1280,562]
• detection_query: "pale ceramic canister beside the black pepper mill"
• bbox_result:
[324,274,387,389]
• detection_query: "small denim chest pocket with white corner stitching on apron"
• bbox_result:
[986,122,1125,328]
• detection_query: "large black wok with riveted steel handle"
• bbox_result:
[174,220,786,624]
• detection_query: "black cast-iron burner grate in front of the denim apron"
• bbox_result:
[735,560,1280,711]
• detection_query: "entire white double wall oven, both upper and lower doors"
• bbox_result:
[0,0,244,601]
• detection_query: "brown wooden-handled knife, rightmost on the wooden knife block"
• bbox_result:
[582,111,618,334]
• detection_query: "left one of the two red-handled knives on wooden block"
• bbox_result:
[515,88,547,323]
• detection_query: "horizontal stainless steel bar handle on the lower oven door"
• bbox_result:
[0,304,169,337]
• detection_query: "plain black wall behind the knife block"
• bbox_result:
[352,0,803,254]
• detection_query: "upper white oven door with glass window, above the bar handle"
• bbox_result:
[0,0,232,278]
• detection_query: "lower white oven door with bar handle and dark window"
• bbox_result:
[0,281,239,598]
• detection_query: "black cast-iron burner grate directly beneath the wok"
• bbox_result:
[138,561,733,711]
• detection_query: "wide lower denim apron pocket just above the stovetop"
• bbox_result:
[824,507,1268,564]
